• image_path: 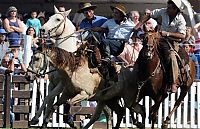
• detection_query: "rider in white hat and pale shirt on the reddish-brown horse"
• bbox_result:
[133,0,186,92]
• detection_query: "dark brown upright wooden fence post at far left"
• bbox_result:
[4,74,11,128]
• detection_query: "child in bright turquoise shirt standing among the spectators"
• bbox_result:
[26,10,41,36]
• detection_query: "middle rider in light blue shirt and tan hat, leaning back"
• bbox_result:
[85,5,134,79]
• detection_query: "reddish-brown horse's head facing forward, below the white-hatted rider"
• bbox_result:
[142,32,160,59]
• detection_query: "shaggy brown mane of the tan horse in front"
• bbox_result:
[46,44,86,72]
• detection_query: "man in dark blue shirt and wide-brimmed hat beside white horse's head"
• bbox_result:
[78,3,107,29]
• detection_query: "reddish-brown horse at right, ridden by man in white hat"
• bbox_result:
[135,32,195,129]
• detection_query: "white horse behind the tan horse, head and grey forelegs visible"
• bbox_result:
[30,6,79,127]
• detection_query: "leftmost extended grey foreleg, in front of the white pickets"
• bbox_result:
[30,83,63,125]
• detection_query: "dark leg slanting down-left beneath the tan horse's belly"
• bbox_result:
[83,101,105,129]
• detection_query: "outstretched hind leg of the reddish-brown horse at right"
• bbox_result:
[162,87,189,129]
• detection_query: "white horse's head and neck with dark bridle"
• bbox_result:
[41,6,78,52]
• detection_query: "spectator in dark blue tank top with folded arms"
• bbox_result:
[3,6,22,47]
